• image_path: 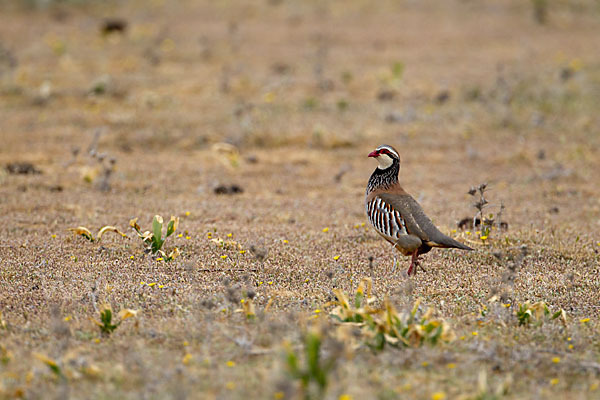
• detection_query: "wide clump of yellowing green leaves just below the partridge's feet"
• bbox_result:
[330,278,454,350]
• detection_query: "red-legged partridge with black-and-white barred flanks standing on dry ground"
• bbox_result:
[365,144,473,276]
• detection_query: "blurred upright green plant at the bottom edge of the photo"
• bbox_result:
[286,328,336,399]
